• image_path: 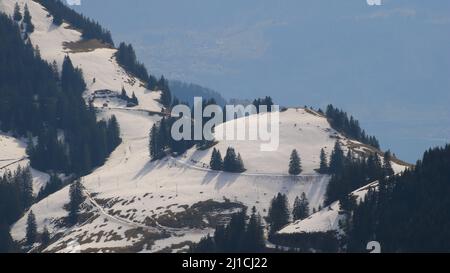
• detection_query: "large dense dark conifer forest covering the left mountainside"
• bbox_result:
[0,14,120,174]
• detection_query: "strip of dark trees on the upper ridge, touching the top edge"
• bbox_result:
[39,0,114,46]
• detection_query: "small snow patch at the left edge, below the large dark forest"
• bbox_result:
[0,133,50,195]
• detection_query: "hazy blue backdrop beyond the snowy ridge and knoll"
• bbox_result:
[76,0,450,161]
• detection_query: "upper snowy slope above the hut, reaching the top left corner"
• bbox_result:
[0,0,161,111]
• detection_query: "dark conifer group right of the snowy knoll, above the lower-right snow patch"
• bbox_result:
[325,142,394,205]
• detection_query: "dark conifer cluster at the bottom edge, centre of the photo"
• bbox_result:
[191,208,265,253]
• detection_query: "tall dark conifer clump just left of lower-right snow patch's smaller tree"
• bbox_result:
[266,193,290,235]
